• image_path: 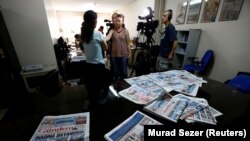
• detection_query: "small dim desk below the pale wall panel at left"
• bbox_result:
[21,66,56,92]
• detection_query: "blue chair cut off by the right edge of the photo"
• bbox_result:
[225,72,250,94]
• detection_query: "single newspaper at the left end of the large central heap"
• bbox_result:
[118,84,160,105]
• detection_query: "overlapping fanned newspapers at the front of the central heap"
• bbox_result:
[144,93,222,125]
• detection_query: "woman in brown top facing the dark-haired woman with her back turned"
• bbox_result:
[105,14,131,80]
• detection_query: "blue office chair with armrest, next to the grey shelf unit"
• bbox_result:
[184,50,214,75]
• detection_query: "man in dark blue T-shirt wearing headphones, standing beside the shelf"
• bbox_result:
[156,9,177,71]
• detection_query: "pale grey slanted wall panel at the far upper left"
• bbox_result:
[0,0,56,66]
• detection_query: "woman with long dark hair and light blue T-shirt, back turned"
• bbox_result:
[81,10,112,110]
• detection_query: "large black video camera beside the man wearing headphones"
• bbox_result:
[136,7,159,43]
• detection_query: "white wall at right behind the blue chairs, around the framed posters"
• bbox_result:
[165,0,250,82]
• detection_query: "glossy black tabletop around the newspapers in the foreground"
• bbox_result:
[21,79,250,141]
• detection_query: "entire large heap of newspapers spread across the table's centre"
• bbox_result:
[119,70,222,124]
